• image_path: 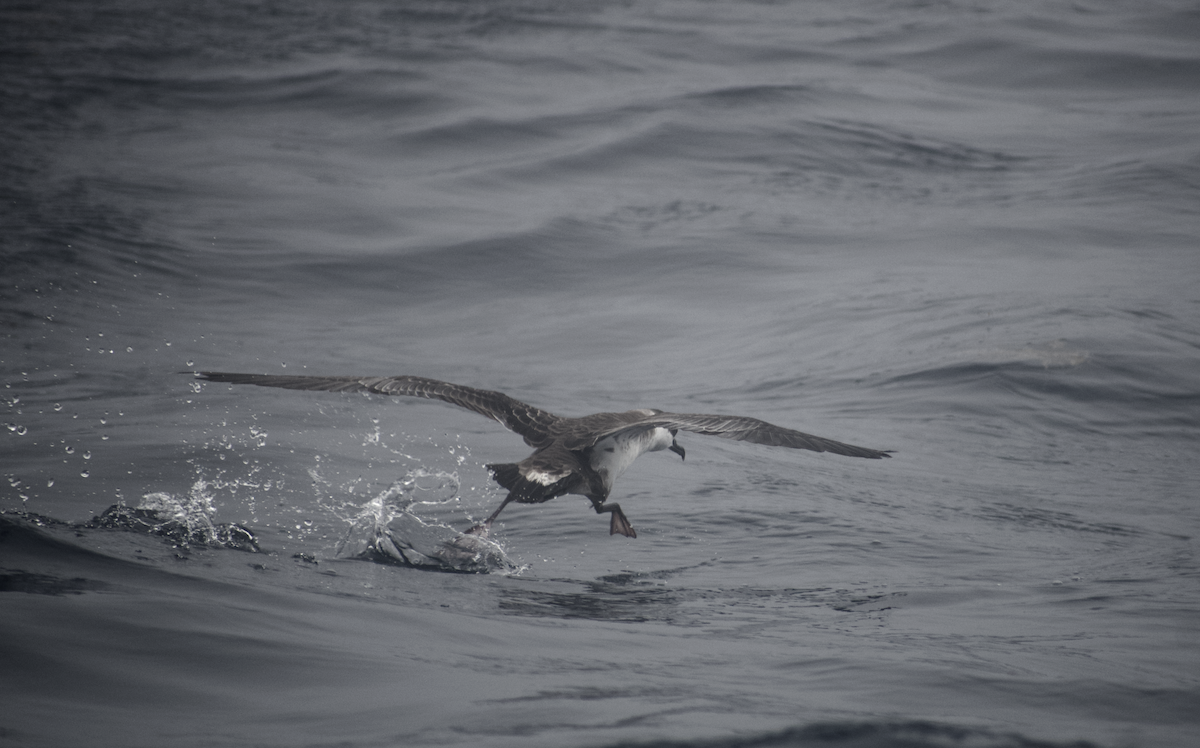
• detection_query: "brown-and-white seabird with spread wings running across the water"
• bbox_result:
[193,371,890,538]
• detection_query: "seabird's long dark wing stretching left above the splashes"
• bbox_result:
[194,371,562,447]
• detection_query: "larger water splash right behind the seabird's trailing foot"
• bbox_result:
[335,468,518,574]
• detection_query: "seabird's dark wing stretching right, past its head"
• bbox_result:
[580,413,892,460]
